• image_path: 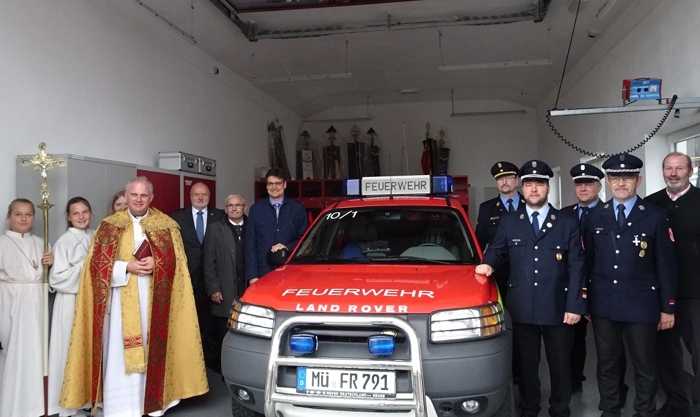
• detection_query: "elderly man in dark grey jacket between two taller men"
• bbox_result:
[204,195,246,372]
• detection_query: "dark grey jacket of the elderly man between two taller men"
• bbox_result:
[203,217,248,317]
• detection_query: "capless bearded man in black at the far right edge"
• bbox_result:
[644,152,700,417]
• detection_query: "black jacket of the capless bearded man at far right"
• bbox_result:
[644,185,700,300]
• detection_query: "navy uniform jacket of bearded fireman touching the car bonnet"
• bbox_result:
[483,204,587,326]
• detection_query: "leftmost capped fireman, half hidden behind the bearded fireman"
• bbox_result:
[474,161,525,300]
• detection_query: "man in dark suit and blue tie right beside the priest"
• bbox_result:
[170,182,225,369]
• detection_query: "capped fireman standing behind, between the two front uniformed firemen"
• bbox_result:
[561,164,605,392]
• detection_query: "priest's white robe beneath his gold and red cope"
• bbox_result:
[102,213,180,417]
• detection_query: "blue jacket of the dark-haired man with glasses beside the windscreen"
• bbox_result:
[245,197,309,279]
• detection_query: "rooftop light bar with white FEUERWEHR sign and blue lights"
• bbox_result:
[343,175,452,196]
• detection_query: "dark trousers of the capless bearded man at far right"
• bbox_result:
[656,299,700,416]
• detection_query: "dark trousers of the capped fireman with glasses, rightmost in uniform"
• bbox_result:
[592,317,657,417]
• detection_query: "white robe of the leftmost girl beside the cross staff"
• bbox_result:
[0,230,57,417]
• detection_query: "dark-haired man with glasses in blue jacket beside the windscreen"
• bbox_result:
[245,168,309,284]
